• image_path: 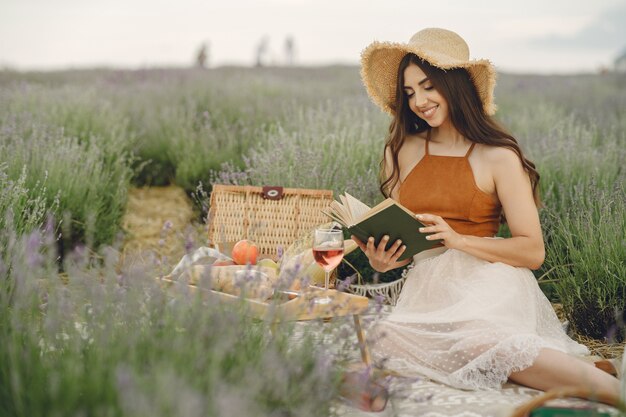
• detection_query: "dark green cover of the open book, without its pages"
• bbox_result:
[348,203,440,261]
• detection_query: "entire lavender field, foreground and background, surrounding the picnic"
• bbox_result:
[0,66,626,416]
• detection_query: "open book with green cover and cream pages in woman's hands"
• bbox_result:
[323,193,440,261]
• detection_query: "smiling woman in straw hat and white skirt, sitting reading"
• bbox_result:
[352,29,619,400]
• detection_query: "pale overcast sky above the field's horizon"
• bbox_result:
[0,0,626,73]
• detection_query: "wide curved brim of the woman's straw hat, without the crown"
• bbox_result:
[361,41,496,115]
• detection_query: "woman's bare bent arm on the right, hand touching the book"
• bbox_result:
[418,147,545,269]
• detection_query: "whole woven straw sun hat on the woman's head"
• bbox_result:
[361,28,496,115]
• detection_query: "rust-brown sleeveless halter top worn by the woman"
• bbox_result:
[398,136,502,237]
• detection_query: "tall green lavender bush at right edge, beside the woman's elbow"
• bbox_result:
[543,180,626,341]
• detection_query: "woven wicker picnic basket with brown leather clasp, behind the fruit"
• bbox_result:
[208,184,333,259]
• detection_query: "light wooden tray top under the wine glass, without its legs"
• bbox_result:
[157,278,368,321]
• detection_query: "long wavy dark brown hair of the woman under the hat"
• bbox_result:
[380,53,541,213]
